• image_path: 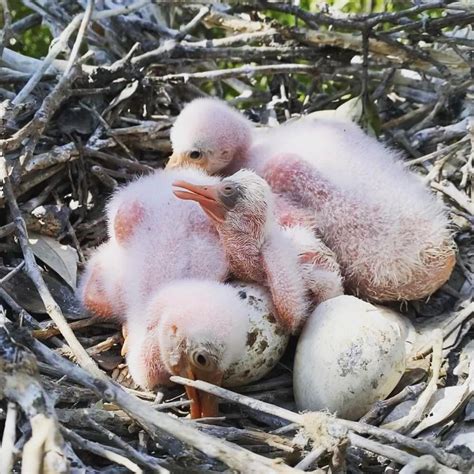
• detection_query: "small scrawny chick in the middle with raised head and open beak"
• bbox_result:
[174,170,343,333]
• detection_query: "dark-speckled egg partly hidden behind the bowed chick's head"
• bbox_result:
[223,282,289,387]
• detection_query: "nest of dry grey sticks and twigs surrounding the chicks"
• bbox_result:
[0,0,474,473]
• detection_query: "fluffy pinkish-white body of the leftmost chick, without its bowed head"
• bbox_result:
[80,169,228,316]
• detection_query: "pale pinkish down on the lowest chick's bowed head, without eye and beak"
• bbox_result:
[127,280,249,388]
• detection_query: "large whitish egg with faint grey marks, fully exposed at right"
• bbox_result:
[293,295,410,420]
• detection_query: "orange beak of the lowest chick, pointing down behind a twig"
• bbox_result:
[177,357,223,420]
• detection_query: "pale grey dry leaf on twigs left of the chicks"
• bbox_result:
[29,234,78,289]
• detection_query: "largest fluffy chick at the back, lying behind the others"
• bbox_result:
[169,99,455,301]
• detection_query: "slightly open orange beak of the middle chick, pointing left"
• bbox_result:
[173,181,227,223]
